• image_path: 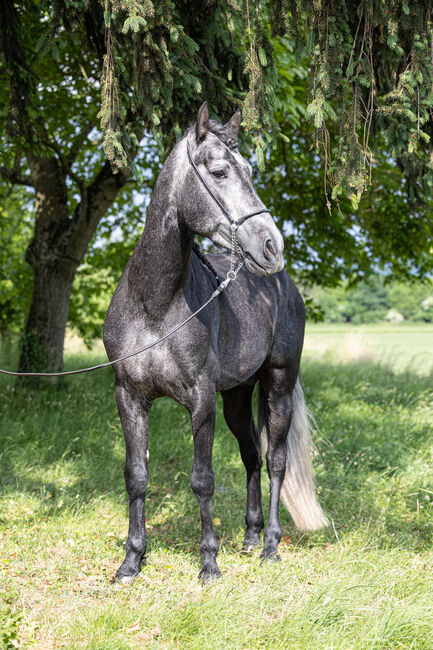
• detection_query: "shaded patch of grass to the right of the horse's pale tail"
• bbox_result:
[298,360,433,550]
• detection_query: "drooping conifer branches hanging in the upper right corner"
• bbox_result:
[286,0,433,206]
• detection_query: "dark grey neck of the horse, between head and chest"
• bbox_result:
[128,144,194,319]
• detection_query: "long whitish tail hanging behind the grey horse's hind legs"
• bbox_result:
[258,376,329,530]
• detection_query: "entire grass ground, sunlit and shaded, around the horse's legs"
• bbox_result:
[0,325,433,650]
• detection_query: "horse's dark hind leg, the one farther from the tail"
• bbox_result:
[221,386,263,551]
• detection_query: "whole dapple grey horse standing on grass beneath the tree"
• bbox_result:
[104,103,327,582]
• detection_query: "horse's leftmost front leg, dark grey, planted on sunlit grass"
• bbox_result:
[115,384,152,583]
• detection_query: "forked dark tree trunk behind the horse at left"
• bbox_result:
[19,155,130,372]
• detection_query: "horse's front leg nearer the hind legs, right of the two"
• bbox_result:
[190,389,221,581]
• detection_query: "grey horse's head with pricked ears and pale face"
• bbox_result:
[177,102,284,275]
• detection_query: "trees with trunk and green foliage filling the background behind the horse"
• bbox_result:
[0,0,433,370]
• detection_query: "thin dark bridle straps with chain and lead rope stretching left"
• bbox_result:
[0,140,270,377]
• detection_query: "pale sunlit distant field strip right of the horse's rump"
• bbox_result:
[304,323,433,374]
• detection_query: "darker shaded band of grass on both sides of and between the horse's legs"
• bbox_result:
[0,350,433,552]
